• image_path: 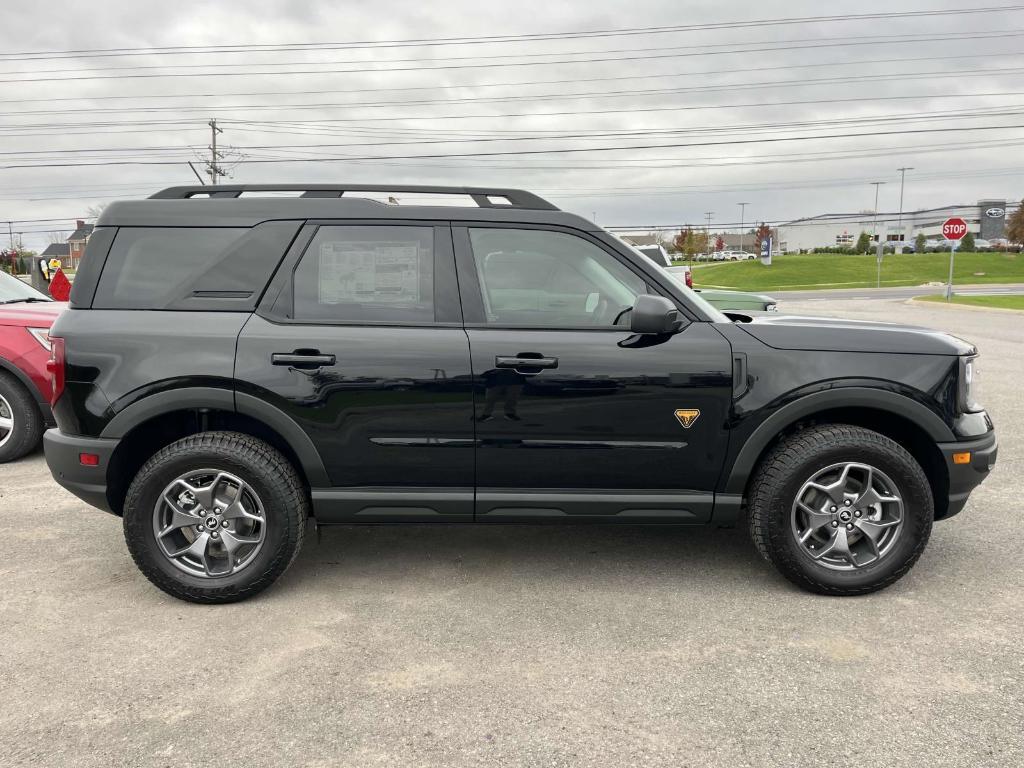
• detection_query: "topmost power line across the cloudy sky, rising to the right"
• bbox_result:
[0,5,1024,60]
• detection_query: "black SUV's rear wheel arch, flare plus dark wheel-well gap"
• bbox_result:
[101,388,330,515]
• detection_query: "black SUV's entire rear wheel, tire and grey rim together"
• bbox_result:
[124,432,309,603]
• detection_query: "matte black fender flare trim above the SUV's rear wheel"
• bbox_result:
[99,387,331,487]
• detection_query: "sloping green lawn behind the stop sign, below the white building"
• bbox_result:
[693,253,1024,291]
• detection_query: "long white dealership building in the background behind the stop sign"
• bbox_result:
[779,200,1017,253]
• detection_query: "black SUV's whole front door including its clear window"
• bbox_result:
[454,225,732,522]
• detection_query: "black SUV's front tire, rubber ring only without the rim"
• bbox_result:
[749,424,935,596]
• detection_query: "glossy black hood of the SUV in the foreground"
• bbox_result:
[737,313,977,354]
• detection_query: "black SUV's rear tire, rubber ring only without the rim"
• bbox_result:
[124,432,309,603]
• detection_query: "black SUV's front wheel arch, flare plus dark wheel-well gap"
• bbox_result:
[724,387,956,518]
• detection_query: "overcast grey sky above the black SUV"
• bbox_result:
[0,0,1024,248]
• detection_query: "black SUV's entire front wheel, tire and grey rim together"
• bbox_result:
[750,424,934,595]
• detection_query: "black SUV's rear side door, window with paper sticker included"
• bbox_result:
[234,223,474,522]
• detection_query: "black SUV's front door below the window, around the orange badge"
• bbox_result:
[468,323,732,522]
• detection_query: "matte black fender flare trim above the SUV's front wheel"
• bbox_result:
[723,387,956,494]
